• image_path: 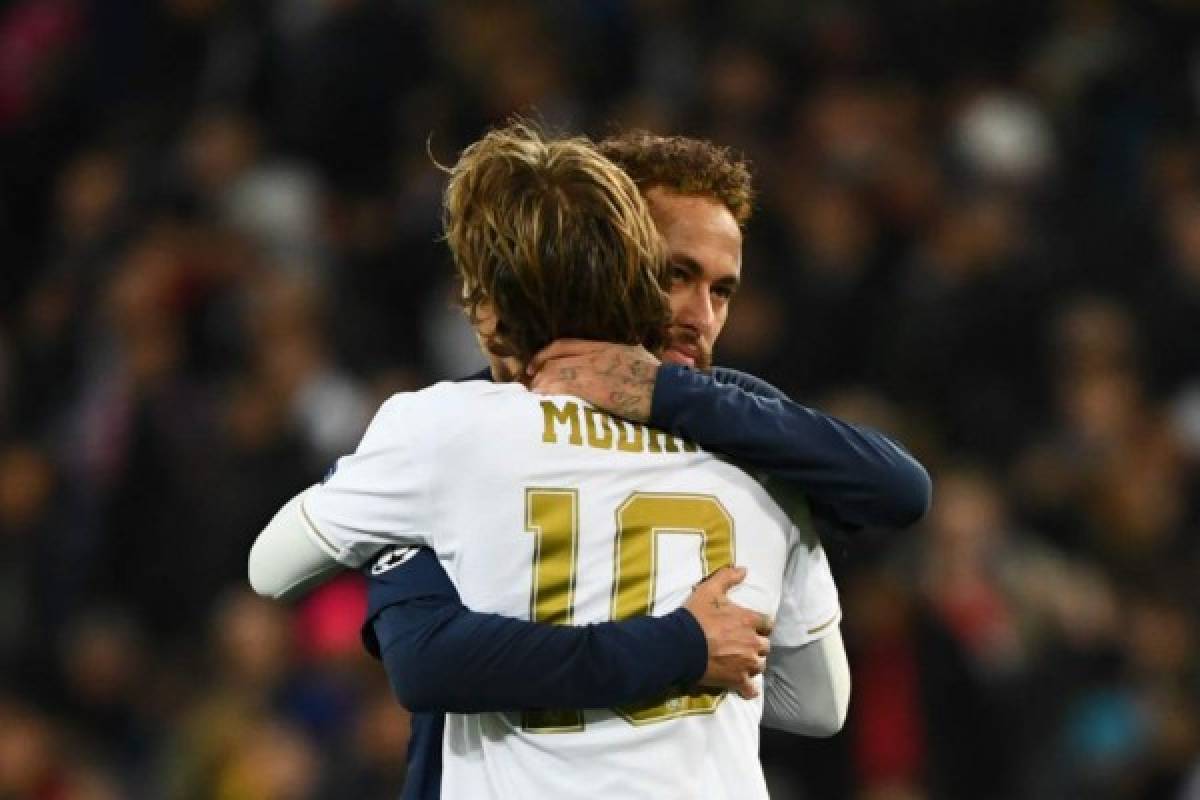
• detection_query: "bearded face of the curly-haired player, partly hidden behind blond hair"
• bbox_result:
[646,187,742,369]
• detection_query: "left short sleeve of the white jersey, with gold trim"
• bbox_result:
[304,392,440,567]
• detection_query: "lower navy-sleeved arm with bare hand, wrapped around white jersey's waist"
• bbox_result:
[364,548,769,712]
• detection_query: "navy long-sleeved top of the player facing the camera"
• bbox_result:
[364,366,930,800]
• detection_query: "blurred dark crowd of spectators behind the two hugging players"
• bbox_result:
[0,0,1200,800]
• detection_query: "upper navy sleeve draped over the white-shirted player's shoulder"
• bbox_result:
[649,365,932,528]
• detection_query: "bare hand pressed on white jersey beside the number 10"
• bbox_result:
[684,566,772,699]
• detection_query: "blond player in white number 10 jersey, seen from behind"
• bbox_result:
[251,125,848,798]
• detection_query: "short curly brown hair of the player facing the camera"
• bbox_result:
[596,131,754,225]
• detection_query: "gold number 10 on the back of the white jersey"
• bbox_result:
[521,488,733,733]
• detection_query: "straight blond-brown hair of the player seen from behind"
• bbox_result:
[443,119,671,365]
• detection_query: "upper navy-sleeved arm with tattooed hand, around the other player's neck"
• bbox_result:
[533,341,931,528]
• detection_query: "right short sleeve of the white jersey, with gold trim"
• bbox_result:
[770,527,841,648]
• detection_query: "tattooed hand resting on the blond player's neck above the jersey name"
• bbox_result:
[527,339,661,422]
